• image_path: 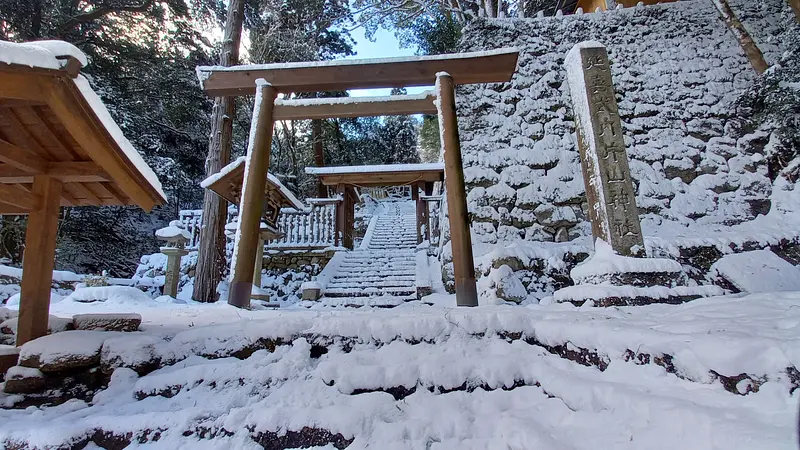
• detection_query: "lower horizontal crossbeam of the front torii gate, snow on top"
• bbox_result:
[275,93,437,120]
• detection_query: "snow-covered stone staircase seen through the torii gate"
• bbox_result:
[322,201,417,307]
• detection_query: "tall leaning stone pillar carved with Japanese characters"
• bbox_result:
[564,41,644,256]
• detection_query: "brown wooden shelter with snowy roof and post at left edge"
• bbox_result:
[0,41,166,345]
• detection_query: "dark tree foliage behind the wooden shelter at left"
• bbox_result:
[0,0,217,276]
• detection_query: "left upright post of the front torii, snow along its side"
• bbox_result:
[228,80,277,308]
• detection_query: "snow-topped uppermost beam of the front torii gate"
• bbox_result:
[197,49,519,97]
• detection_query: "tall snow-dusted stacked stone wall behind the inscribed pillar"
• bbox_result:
[442,0,788,298]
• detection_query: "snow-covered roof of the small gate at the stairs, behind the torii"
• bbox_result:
[306,163,444,187]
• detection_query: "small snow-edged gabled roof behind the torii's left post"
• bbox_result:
[200,156,303,209]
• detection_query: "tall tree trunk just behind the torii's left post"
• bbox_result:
[192,0,244,302]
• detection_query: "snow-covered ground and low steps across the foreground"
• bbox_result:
[0,292,800,450]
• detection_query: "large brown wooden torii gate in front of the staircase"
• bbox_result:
[197,49,519,307]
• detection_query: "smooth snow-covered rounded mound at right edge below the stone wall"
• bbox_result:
[711,250,800,293]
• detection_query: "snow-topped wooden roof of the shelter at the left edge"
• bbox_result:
[0,41,166,214]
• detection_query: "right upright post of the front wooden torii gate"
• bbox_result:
[436,72,478,306]
